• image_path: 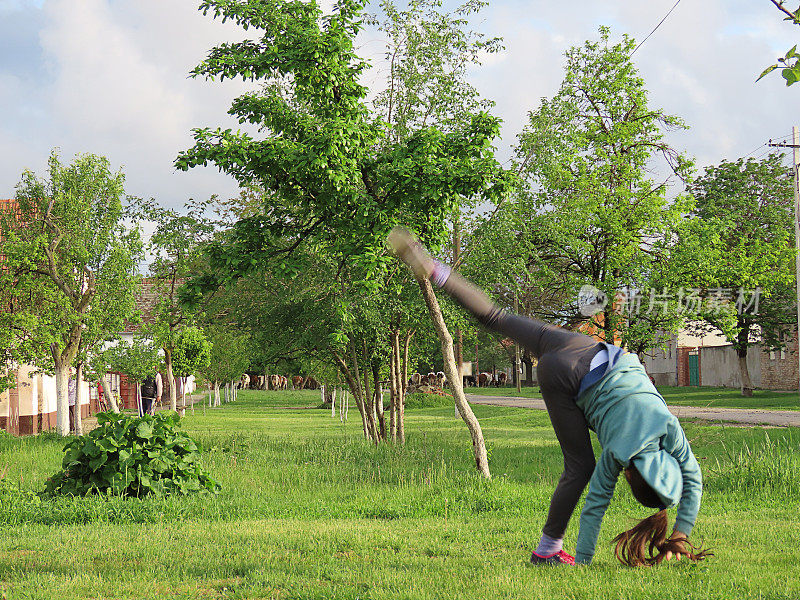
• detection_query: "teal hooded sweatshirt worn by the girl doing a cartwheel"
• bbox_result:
[575,354,703,564]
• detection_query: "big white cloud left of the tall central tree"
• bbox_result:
[0,0,256,206]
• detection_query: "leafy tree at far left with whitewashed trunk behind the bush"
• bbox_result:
[0,152,141,435]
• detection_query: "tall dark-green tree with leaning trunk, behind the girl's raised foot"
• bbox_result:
[176,0,505,476]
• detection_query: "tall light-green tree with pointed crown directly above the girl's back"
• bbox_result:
[508,28,691,349]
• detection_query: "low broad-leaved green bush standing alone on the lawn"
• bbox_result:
[45,412,219,498]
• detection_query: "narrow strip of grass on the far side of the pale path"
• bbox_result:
[465,386,800,410]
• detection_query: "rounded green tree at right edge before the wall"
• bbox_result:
[676,154,796,396]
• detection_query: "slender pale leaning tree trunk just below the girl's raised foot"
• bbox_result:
[417,279,492,479]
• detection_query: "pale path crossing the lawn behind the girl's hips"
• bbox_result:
[467,394,800,427]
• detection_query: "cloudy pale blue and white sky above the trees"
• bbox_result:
[0,0,800,206]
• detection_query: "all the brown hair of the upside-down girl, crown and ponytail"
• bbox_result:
[614,466,714,567]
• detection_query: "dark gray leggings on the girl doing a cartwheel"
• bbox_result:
[442,273,602,538]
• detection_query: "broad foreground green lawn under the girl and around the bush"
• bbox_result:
[0,392,800,600]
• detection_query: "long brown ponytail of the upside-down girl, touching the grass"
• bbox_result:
[614,510,714,567]
